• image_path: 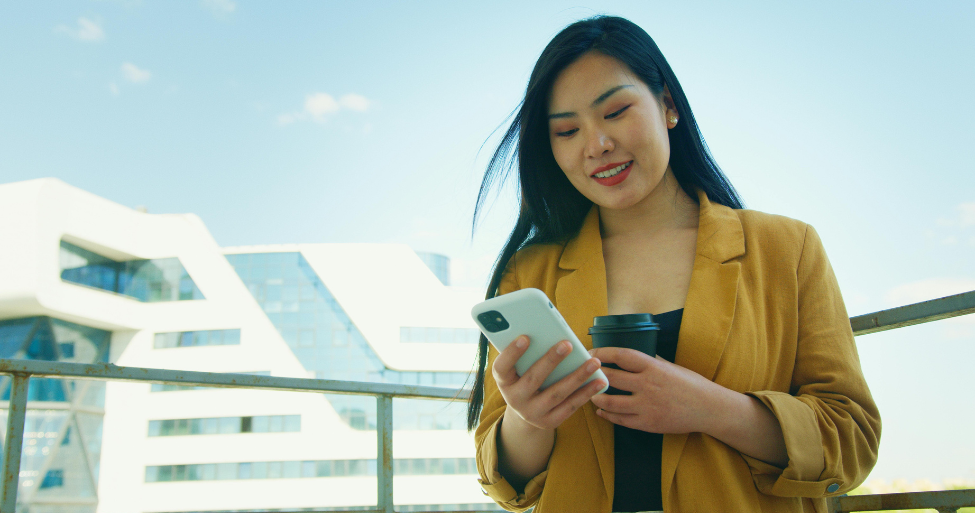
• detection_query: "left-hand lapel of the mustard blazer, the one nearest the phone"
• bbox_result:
[555,206,615,497]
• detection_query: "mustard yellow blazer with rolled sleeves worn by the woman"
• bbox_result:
[475,193,880,513]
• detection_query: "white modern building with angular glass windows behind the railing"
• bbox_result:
[0,179,504,513]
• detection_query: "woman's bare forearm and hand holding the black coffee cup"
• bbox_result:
[590,347,789,468]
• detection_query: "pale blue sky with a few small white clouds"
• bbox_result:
[0,0,975,481]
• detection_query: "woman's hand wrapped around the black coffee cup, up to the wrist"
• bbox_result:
[590,347,723,433]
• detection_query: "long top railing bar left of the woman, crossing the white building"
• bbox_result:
[0,359,470,401]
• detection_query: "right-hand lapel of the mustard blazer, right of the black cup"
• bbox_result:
[661,191,745,504]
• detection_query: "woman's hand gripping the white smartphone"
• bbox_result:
[491,335,606,430]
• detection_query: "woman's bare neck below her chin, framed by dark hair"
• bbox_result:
[599,167,700,239]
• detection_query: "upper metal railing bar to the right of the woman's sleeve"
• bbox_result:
[850,290,975,335]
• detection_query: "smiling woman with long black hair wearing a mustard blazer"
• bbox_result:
[468,17,880,513]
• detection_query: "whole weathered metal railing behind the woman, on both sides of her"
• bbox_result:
[0,291,975,513]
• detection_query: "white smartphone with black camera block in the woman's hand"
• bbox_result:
[471,289,609,394]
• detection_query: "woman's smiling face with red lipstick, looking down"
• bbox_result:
[548,52,677,209]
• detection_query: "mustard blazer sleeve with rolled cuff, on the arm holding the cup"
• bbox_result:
[744,226,880,497]
